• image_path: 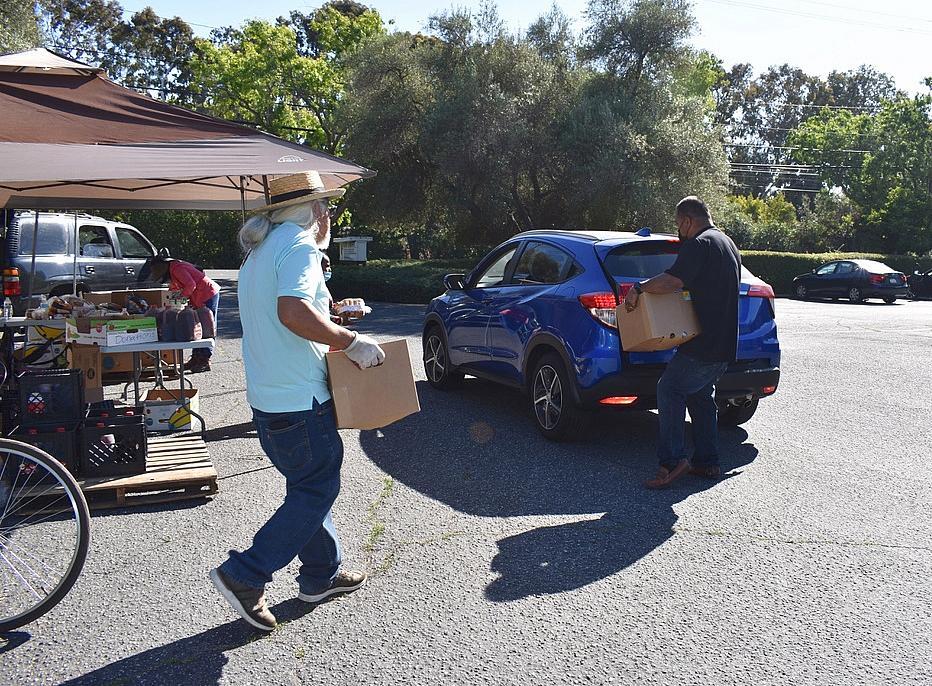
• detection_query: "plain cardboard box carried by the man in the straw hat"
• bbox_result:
[327,340,421,429]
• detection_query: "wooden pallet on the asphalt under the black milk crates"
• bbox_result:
[78,434,217,510]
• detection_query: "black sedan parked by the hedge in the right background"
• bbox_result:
[793,260,909,303]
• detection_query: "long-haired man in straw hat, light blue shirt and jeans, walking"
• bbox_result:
[210,172,385,631]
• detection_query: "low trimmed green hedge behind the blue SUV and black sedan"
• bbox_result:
[328,251,932,303]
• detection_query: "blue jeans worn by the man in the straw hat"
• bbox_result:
[220,400,343,594]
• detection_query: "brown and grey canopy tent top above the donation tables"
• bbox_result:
[0,48,375,210]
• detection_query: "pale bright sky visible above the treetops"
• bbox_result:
[122,0,932,92]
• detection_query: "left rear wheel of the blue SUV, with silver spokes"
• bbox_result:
[528,353,589,441]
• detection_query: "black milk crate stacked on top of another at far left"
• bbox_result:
[18,369,84,426]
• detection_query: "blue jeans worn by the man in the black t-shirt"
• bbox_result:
[657,352,728,469]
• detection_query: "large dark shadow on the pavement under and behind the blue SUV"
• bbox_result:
[360,379,757,602]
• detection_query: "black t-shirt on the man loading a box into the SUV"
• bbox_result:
[667,226,741,362]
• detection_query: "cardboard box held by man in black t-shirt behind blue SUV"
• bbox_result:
[615,291,700,353]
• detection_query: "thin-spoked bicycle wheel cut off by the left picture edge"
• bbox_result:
[0,439,90,633]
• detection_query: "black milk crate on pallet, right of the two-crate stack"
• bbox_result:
[79,414,148,478]
